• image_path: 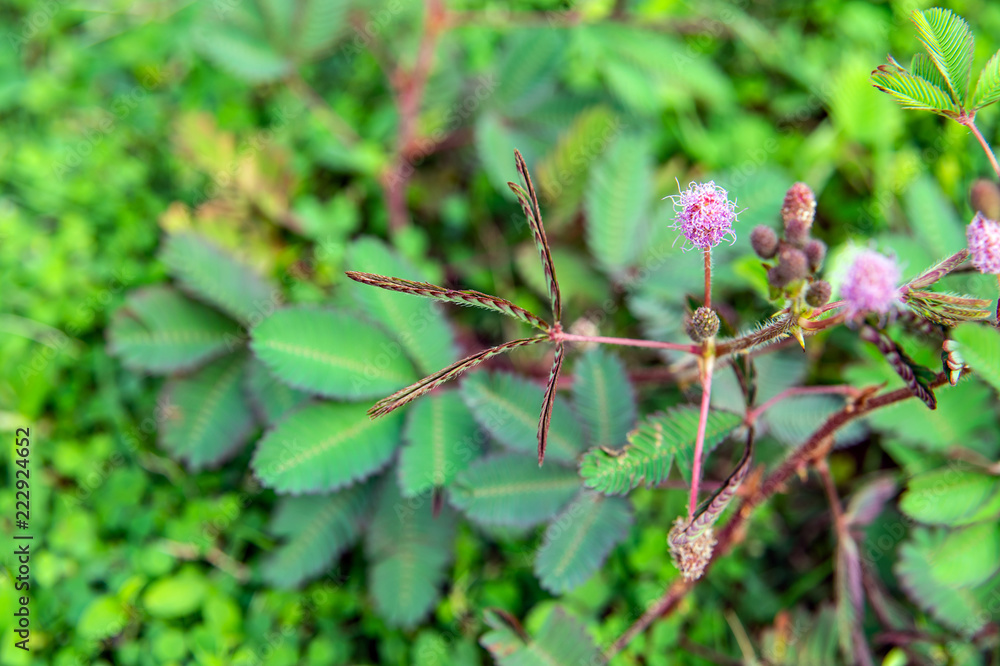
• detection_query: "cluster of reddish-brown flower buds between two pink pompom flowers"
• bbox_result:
[750,183,830,296]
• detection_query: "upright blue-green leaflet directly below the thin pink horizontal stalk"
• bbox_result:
[573,347,636,448]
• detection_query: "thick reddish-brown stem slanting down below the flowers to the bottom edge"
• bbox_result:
[604,373,948,660]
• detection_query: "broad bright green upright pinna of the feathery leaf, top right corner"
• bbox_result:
[911,7,972,108]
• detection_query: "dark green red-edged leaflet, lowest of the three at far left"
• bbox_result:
[160,354,254,469]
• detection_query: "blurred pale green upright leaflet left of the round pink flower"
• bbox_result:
[584,134,653,276]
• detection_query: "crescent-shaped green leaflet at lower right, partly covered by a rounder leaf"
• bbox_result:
[894,527,996,636]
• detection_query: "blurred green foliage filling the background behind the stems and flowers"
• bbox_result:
[0,0,1000,665]
